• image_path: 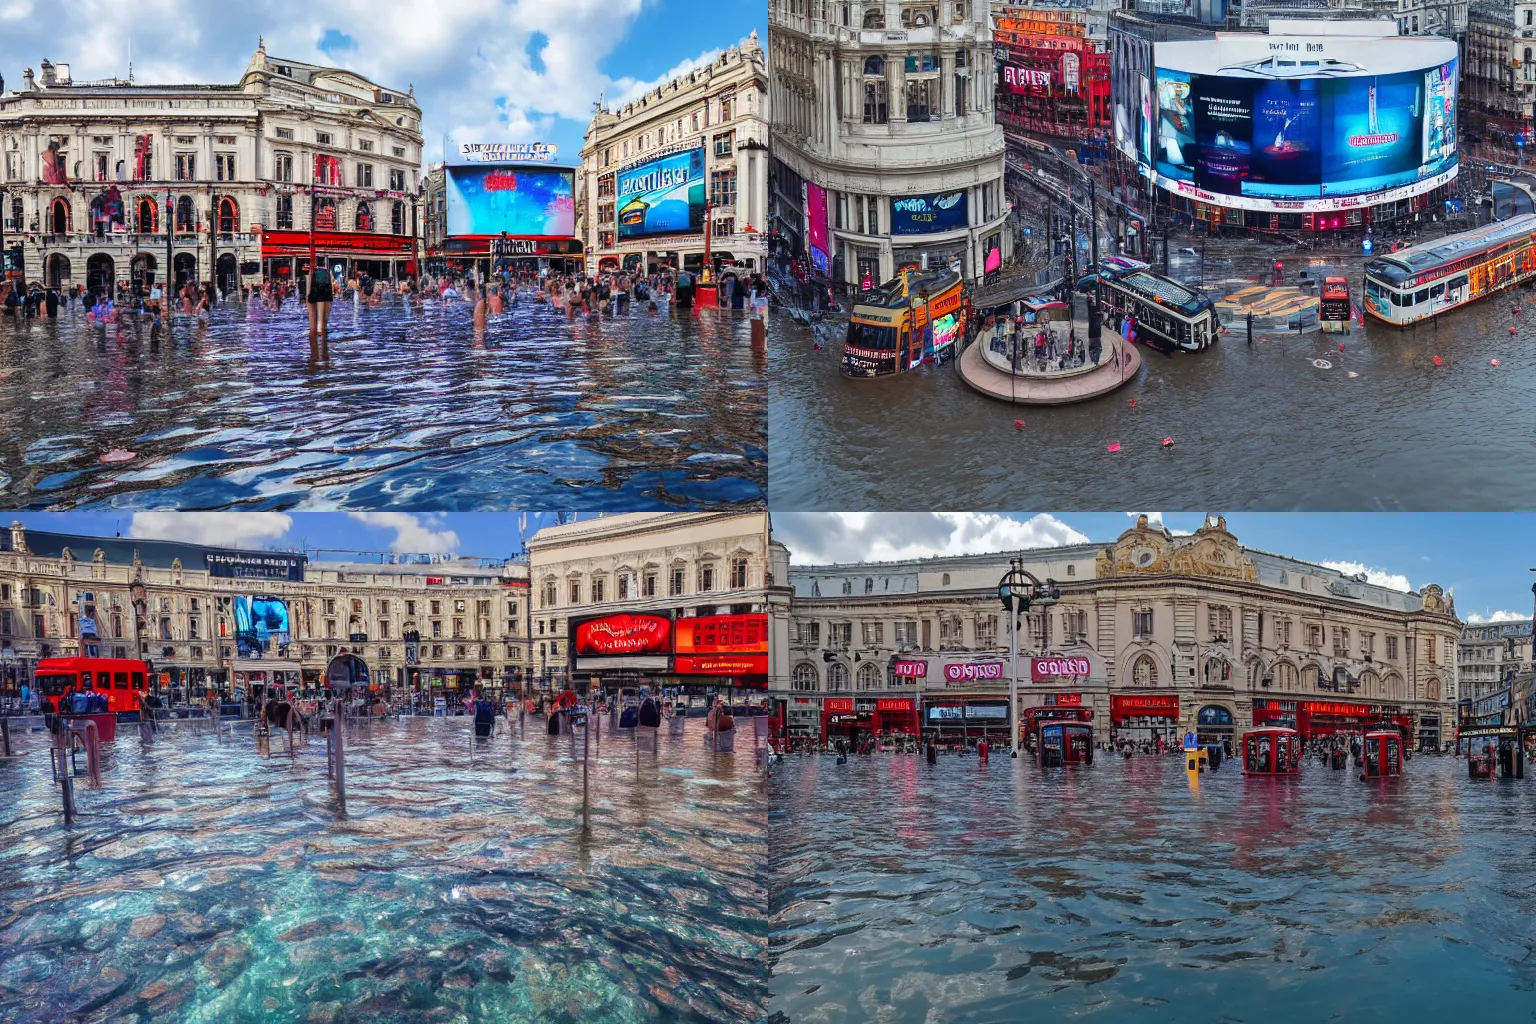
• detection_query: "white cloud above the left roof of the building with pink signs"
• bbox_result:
[773,513,1087,565]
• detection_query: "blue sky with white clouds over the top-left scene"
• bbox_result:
[0,0,768,163]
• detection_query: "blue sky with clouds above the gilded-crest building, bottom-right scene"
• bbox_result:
[773,511,1536,622]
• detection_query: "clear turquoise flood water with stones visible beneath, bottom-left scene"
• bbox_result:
[0,718,766,1024]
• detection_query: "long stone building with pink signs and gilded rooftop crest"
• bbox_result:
[773,516,1461,745]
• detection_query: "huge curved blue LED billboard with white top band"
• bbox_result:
[1149,35,1456,210]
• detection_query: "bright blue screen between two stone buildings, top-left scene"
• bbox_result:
[445,164,576,238]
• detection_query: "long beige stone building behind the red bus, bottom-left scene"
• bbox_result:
[0,522,530,692]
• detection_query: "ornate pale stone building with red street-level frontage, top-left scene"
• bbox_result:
[0,46,421,292]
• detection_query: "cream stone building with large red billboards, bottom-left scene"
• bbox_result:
[528,513,770,689]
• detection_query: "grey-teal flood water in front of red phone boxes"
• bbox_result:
[768,754,1536,1024]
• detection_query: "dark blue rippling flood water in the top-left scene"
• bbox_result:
[0,299,768,511]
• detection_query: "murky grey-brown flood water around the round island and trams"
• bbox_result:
[768,245,1536,511]
